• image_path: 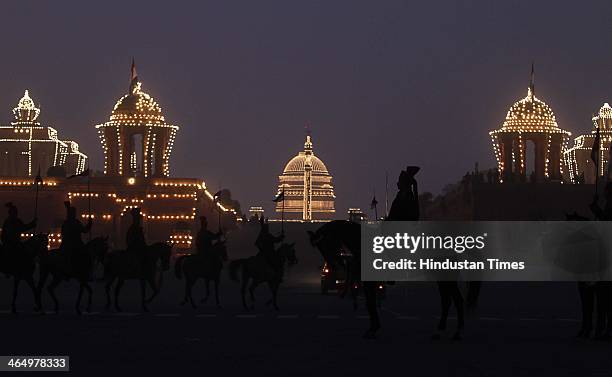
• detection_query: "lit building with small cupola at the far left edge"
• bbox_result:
[0,90,87,177]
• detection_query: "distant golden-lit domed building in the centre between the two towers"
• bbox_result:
[276,133,336,221]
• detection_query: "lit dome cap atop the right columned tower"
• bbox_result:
[502,87,559,131]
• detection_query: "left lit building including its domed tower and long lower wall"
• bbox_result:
[0,62,240,248]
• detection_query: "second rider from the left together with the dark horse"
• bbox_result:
[38,202,108,314]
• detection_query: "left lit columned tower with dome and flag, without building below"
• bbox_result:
[96,62,179,177]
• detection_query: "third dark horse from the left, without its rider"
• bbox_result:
[104,242,172,312]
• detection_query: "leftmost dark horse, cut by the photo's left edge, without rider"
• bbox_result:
[0,234,49,313]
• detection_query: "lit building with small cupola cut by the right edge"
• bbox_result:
[565,102,612,184]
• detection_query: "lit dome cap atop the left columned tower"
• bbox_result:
[110,82,164,123]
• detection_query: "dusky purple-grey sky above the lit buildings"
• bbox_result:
[0,0,612,217]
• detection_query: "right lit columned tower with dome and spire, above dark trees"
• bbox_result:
[489,67,571,182]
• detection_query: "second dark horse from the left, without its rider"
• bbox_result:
[38,237,108,314]
